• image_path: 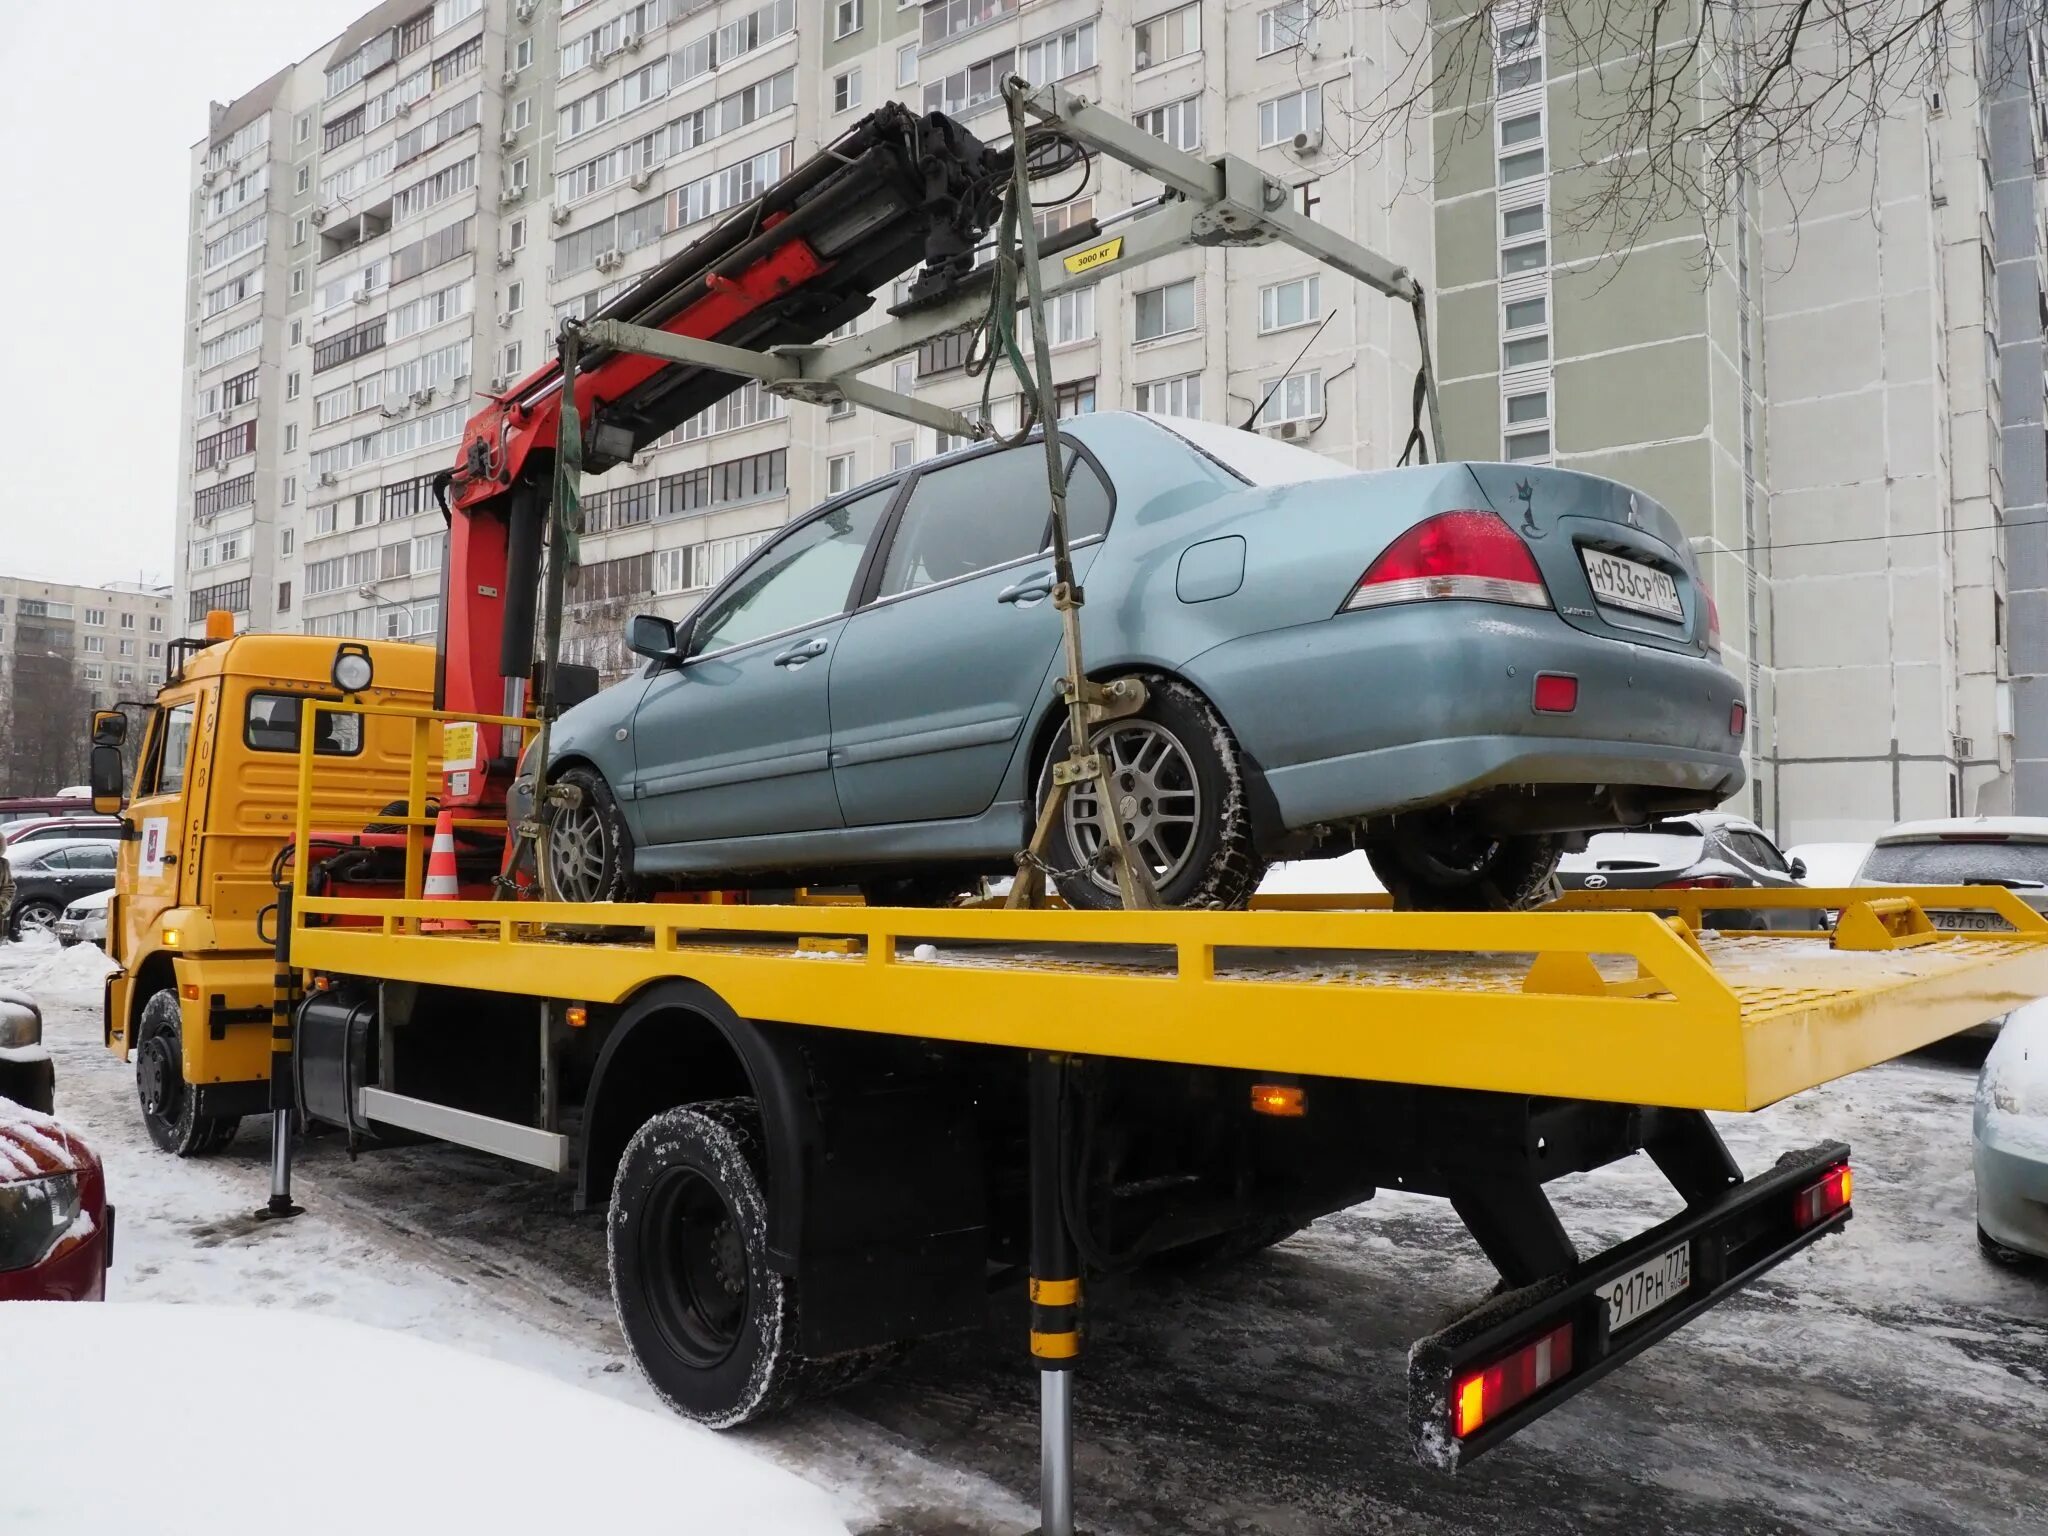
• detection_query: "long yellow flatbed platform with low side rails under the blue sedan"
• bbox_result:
[293,707,2048,1110]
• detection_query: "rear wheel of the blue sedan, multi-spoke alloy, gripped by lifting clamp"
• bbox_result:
[1036,678,1266,911]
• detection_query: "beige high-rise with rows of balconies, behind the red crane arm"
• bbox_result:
[178,0,1432,666]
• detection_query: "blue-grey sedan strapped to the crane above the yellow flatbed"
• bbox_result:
[528,412,1745,907]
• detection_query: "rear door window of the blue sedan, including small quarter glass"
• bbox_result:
[877,442,1110,598]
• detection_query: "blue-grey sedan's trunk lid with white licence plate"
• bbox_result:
[1470,463,1710,655]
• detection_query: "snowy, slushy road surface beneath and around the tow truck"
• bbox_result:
[16,948,2048,1536]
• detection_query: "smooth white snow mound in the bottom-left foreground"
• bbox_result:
[0,1303,846,1536]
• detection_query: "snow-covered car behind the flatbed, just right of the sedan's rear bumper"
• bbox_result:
[1556,811,1825,928]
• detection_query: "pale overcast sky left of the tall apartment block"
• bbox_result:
[0,0,375,584]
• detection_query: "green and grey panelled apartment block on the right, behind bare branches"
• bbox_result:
[1434,0,2048,842]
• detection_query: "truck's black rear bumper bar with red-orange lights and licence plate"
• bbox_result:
[1409,1141,1851,1473]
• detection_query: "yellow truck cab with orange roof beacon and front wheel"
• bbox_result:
[92,621,434,1153]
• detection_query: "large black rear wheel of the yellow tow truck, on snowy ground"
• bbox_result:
[606,1098,895,1430]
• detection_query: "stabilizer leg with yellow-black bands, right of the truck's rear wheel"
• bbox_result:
[1030,1051,1081,1536]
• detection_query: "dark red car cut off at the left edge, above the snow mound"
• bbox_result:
[0,1098,115,1300]
